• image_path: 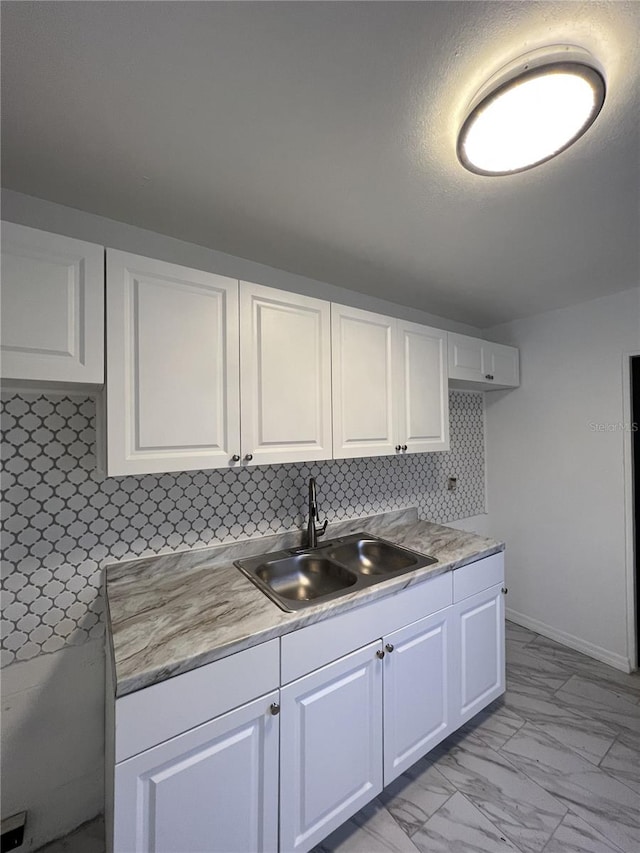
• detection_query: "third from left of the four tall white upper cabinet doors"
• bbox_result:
[331,304,396,459]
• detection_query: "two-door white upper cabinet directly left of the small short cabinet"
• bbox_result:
[331,304,449,458]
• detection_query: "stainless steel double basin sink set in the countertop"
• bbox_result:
[235,533,438,612]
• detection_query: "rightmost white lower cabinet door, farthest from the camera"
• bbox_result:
[451,584,505,729]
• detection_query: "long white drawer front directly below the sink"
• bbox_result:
[281,572,453,684]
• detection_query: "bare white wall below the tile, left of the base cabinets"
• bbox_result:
[2,639,104,851]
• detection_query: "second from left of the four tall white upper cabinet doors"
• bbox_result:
[240,282,332,465]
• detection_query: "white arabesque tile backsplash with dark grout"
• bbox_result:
[0,391,484,666]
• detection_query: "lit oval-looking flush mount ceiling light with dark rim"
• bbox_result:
[458,45,605,175]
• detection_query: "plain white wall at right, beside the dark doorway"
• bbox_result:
[485,288,640,668]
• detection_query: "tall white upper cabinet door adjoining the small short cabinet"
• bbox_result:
[397,320,449,453]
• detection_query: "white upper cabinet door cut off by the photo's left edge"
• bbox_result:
[1,222,104,385]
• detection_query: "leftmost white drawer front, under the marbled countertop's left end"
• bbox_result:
[115,639,280,762]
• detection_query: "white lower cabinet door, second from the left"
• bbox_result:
[282,641,384,853]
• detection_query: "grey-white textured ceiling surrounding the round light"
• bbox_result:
[2,2,640,327]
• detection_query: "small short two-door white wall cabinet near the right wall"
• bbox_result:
[448,332,520,391]
